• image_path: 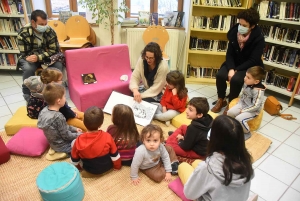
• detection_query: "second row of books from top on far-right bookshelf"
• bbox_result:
[259,24,300,44]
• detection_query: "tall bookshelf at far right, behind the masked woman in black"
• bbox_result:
[258,0,300,106]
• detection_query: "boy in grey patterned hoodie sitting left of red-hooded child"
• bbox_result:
[37,83,82,154]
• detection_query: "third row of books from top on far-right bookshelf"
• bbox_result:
[263,44,300,68]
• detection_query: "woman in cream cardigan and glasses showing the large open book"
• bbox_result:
[129,42,169,103]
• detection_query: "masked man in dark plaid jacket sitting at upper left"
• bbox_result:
[17,10,63,101]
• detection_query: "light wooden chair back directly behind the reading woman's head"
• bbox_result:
[143,25,170,61]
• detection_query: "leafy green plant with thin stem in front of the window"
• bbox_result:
[79,0,129,45]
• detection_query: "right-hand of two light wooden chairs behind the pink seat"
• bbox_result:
[59,15,92,50]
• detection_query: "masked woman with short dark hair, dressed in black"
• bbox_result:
[211,8,265,114]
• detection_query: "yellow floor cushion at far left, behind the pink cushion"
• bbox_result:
[4,106,37,135]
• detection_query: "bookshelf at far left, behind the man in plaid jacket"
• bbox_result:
[0,0,32,70]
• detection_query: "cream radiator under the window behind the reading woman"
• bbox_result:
[121,28,184,70]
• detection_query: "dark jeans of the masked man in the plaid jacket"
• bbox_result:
[18,59,64,97]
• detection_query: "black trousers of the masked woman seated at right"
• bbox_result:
[216,66,247,102]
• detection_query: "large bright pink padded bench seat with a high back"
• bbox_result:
[65,44,132,111]
